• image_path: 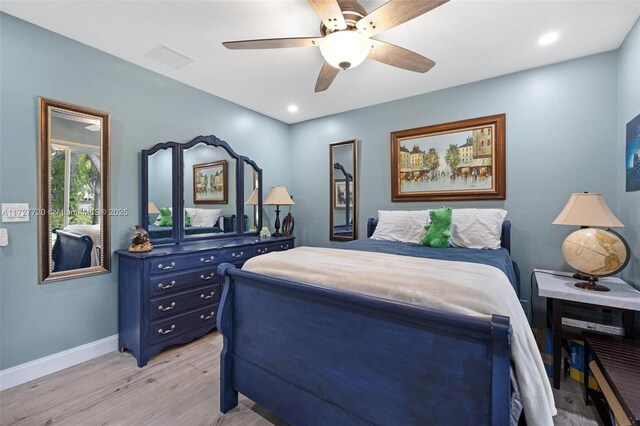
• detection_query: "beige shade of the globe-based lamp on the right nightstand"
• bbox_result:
[552,192,624,228]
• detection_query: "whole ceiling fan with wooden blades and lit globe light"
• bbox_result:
[222,0,449,92]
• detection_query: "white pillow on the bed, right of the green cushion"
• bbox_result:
[449,209,507,250]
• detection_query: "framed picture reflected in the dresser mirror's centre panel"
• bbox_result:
[193,160,227,204]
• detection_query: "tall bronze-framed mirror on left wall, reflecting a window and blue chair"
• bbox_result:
[38,98,111,283]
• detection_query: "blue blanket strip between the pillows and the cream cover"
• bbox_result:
[336,238,520,295]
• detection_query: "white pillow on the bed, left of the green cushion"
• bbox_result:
[371,210,430,244]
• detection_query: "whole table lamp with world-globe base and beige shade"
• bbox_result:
[552,192,630,291]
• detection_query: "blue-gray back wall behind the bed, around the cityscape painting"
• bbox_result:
[291,52,619,321]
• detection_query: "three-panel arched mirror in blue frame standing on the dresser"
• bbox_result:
[141,136,262,245]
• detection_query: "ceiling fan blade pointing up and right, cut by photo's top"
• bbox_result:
[356,0,449,37]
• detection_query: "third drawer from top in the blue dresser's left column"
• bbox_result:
[149,284,220,322]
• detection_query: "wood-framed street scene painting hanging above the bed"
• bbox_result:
[391,114,506,201]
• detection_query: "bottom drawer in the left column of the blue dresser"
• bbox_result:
[149,304,218,345]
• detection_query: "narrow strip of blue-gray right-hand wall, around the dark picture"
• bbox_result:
[615,19,640,289]
